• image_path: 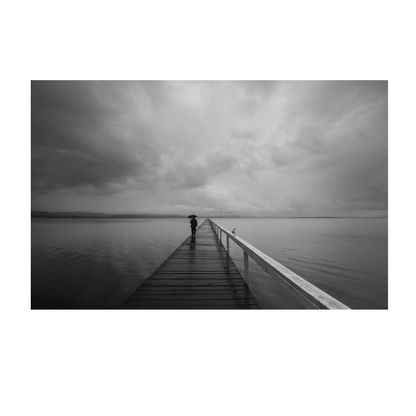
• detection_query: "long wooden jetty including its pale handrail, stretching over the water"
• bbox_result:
[121,220,349,309]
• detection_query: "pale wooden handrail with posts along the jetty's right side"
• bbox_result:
[208,218,350,309]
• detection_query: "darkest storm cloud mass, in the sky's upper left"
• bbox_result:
[32,81,163,190]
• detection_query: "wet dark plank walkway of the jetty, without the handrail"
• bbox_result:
[121,220,260,309]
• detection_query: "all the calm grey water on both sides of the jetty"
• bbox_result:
[32,218,387,309]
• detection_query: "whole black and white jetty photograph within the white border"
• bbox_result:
[30,78,389,313]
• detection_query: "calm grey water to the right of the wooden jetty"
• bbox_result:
[216,218,387,309]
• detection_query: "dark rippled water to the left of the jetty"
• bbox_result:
[31,219,200,309]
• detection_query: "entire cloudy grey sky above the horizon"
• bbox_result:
[31,81,387,216]
